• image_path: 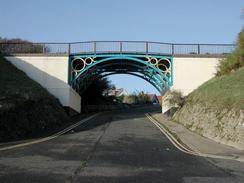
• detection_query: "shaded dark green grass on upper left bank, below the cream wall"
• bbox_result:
[0,56,50,100]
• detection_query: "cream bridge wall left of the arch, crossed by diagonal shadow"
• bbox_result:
[6,56,81,112]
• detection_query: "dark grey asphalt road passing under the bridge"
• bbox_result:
[0,107,244,183]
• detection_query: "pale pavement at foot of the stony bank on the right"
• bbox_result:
[152,113,244,162]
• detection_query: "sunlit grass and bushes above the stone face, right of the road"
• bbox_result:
[187,29,244,109]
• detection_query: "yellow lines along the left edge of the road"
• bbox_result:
[0,113,101,151]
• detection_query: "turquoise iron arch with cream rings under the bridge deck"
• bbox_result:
[69,53,173,93]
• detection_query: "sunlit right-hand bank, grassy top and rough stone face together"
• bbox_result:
[173,67,244,150]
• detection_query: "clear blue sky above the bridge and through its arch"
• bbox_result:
[0,0,244,92]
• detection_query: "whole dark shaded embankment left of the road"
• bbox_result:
[0,56,68,141]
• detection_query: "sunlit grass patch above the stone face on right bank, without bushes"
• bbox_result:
[187,67,244,110]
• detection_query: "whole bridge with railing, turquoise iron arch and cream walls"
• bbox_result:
[0,41,235,113]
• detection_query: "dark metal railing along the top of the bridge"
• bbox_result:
[0,41,235,55]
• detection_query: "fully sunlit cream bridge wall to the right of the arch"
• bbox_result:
[171,57,219,95]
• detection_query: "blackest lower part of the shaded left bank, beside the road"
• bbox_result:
[0,95,68,142]
